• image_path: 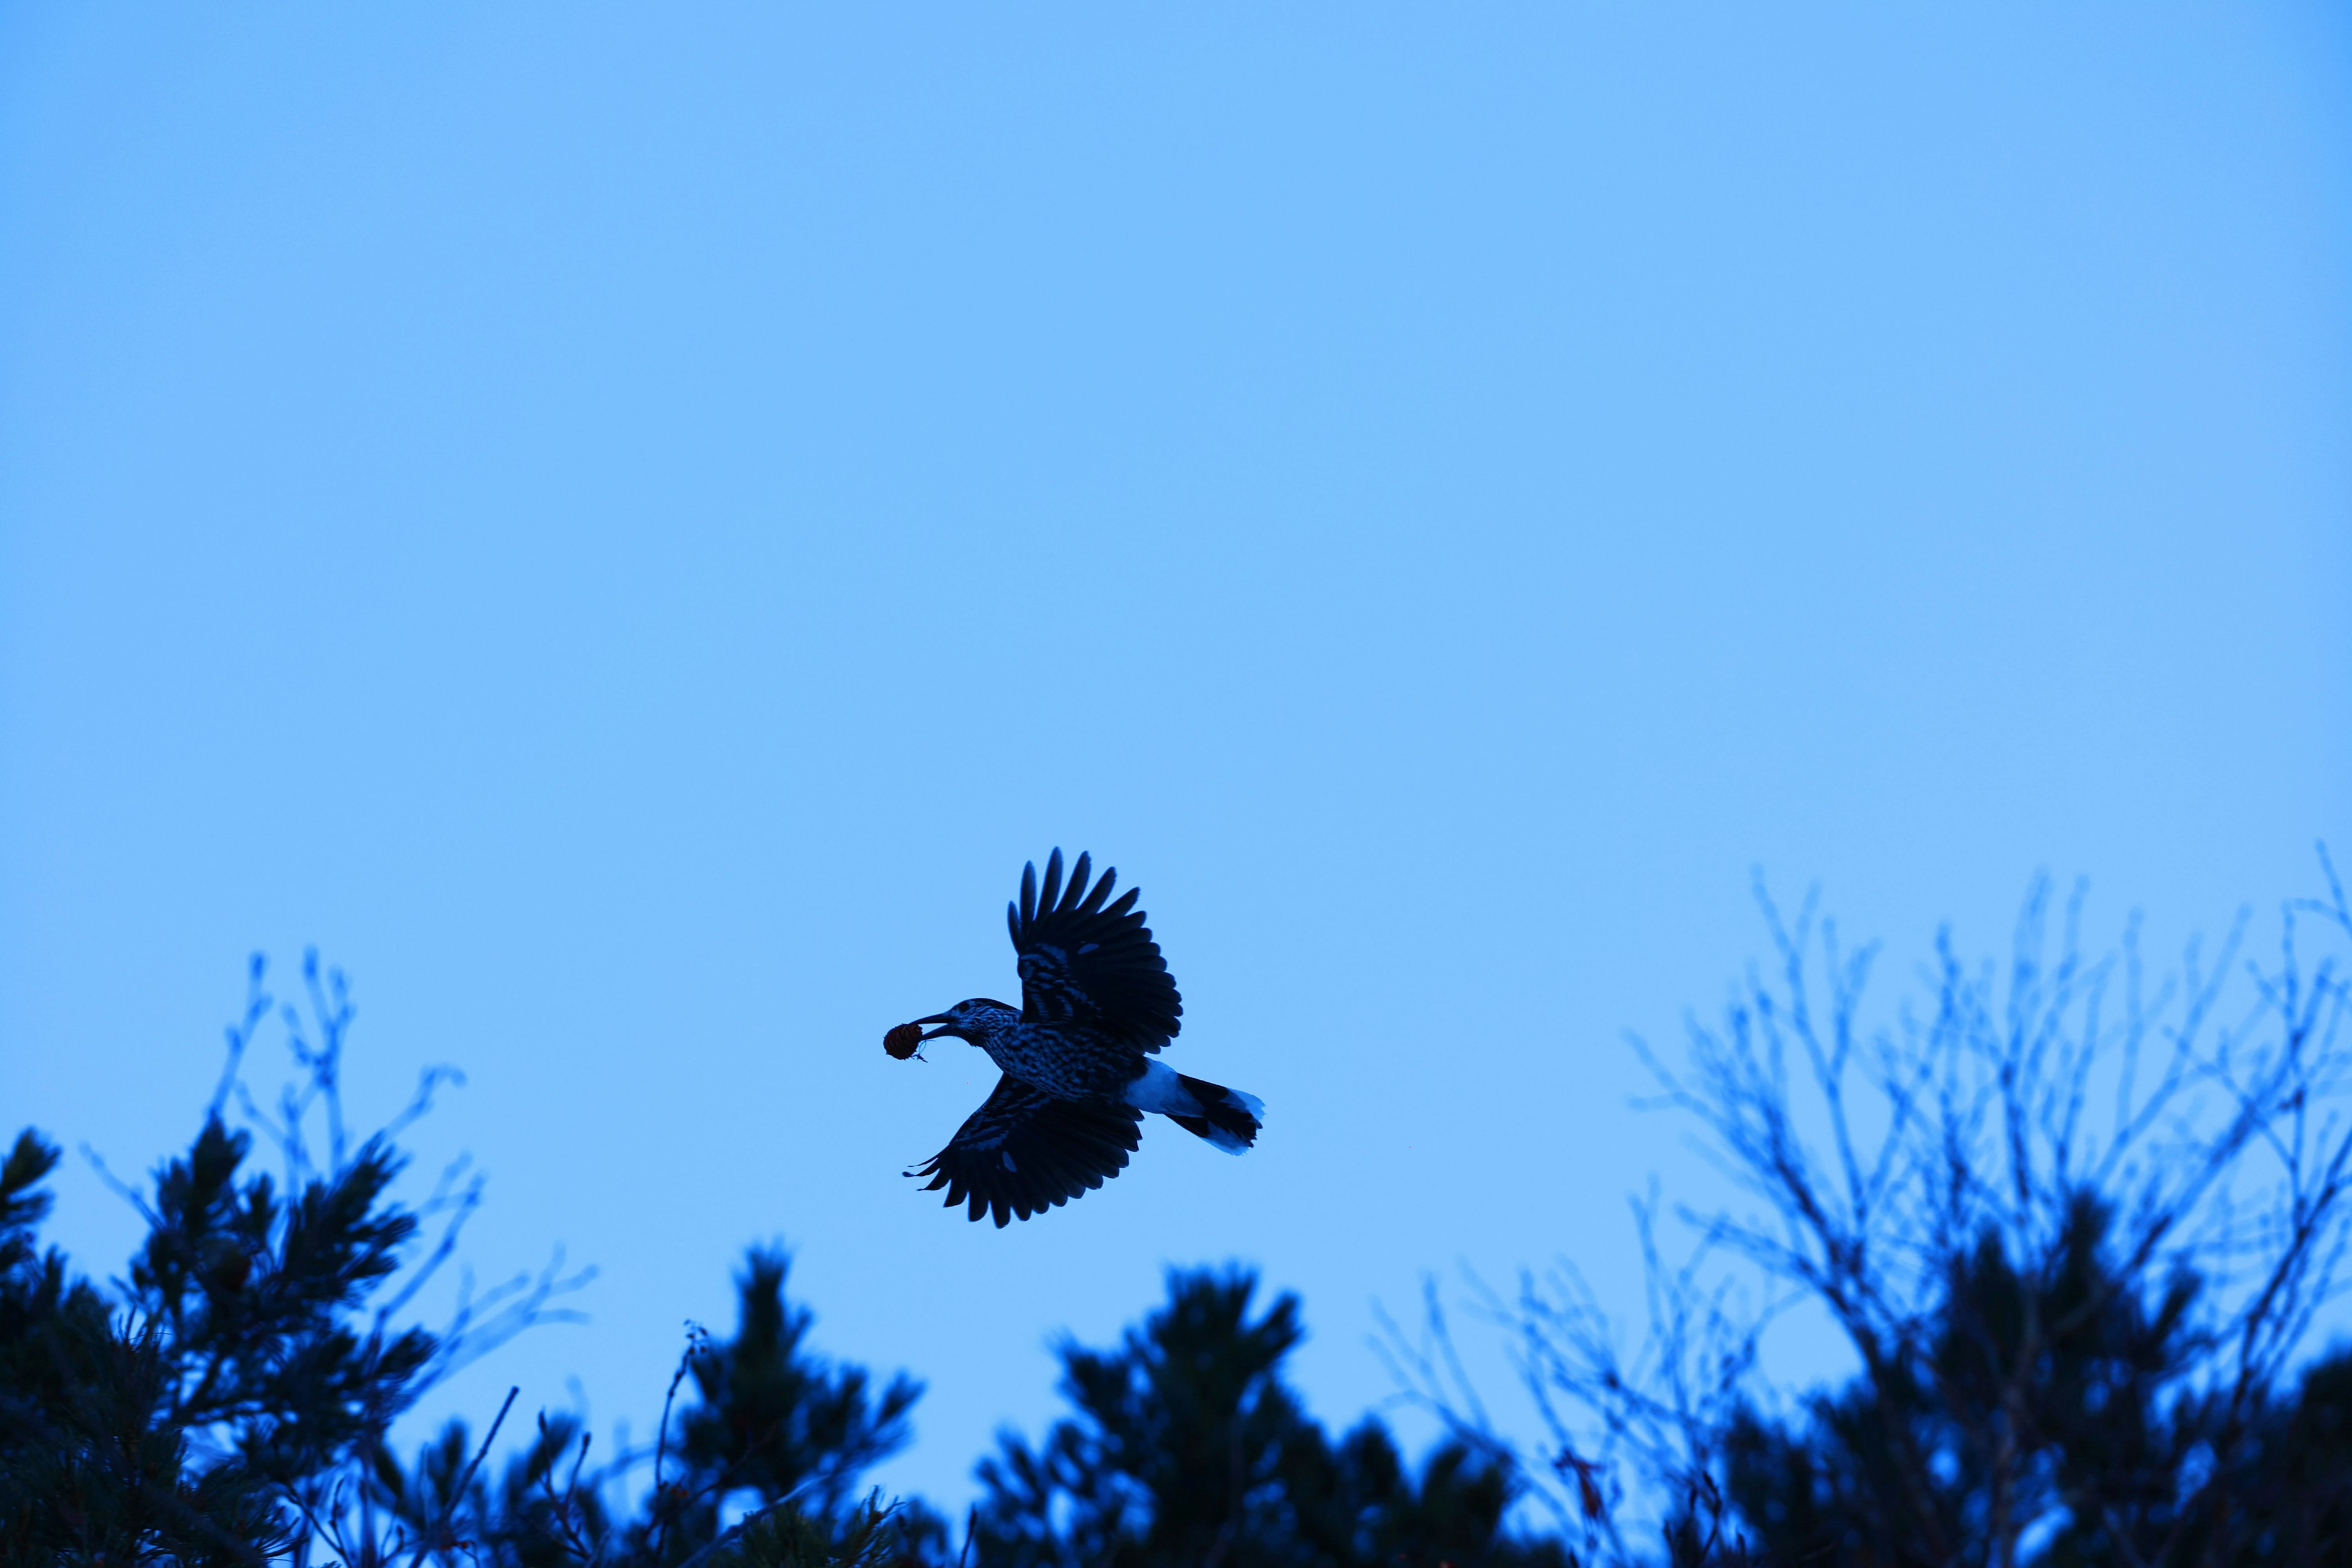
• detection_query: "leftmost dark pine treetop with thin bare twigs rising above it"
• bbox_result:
[0,962,491,1563]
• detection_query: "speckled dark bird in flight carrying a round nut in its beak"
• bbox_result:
[882,849,1265,1227]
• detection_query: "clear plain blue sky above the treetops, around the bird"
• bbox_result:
[0,2,2352,1507]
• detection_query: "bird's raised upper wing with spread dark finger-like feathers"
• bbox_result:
[1005,849,1183,1051]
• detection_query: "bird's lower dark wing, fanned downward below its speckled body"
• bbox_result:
[908,1077,1143,1227]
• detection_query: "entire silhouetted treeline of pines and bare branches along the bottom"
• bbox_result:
[18,875,2352,1568]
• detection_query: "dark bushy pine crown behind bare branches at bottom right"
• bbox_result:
[1724,1199,2352,1568]
